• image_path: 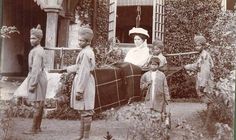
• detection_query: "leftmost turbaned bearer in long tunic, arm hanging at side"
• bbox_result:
[24,25,47,134]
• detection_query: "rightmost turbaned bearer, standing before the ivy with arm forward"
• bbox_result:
[184,35,214,126]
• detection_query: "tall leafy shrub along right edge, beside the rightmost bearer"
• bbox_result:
[200,11,236,135]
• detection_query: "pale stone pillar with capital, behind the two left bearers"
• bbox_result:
[44,8,60,69]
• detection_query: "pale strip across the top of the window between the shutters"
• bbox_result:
[117,0,153,6]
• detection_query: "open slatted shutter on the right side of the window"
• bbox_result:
[152,0,165,41]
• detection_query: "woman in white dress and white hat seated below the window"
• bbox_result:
[124,27,150,67]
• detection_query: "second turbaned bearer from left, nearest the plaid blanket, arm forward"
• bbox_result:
[62,27,95,140]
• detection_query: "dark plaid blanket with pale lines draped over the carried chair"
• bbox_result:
[93,63,142,112]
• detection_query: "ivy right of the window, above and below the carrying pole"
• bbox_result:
[164,0,220,98]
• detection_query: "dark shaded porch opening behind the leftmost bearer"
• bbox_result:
[0,0,46,75]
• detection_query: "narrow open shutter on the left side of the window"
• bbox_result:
[108,0,117,39]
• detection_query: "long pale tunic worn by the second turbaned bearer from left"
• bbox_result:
[67,46,95,110]
